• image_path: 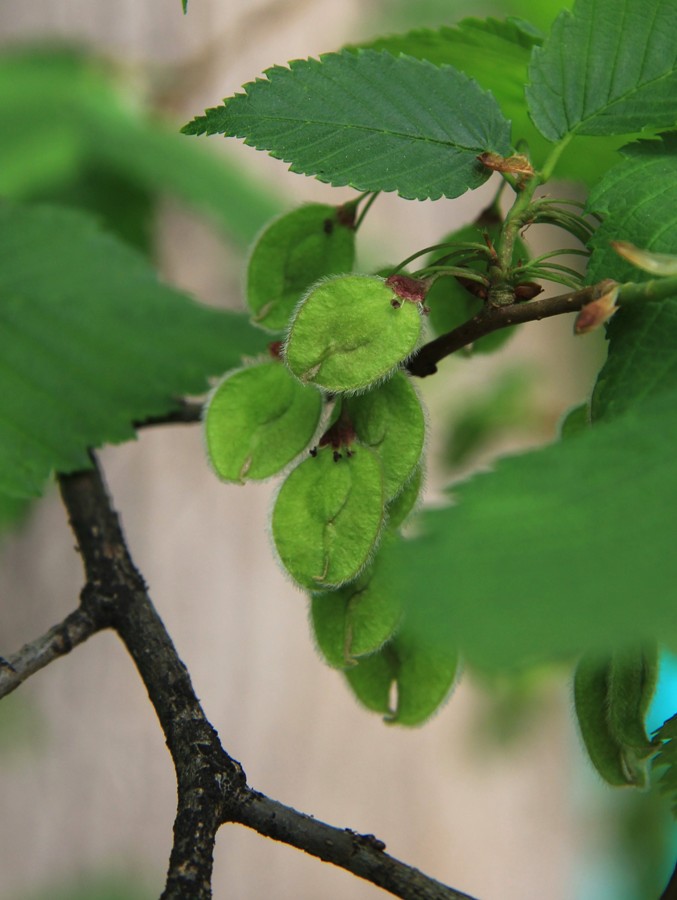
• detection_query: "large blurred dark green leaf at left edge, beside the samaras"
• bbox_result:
[0,202,260,496]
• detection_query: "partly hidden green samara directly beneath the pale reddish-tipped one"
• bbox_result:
[345,372,425,502]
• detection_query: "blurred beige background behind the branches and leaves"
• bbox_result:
[0,0,604,900]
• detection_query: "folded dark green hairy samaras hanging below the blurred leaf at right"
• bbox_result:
[574,645,658,787]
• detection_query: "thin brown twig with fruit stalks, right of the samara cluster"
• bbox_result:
[407,281,611,378]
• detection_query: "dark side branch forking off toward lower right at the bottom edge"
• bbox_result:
[238,791,473,900]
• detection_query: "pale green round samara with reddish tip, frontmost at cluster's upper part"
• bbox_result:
[284,275,421,393]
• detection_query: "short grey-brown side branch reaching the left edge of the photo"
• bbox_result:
[0,606,106,698]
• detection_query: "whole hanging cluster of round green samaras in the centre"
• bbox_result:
[205,201,481,724]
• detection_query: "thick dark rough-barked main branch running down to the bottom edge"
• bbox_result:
[60,468,245,900]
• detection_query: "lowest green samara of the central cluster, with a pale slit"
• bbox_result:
[345,623,458,726]
